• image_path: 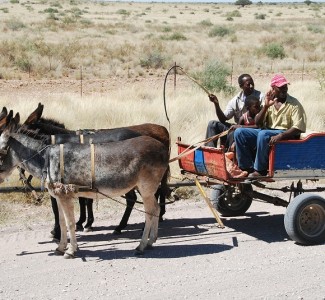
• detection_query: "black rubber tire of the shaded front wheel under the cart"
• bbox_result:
[210,184,253,217]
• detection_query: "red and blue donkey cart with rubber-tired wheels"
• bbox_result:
[177,132,325,245]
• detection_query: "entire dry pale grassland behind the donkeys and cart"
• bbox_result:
[0,0,325,226]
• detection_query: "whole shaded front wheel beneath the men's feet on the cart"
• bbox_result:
[210,184,252,217]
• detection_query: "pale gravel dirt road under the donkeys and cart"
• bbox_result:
[0,200,325,300]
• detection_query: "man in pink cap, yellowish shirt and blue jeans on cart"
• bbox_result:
[234,75,306,177]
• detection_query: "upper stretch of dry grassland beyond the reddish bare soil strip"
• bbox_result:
[0,0,325,79]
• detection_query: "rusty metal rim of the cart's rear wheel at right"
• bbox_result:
[299,204,325,237]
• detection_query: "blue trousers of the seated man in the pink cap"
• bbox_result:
[234,128,284,172]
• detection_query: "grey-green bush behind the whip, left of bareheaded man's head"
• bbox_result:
[193,61,235,94]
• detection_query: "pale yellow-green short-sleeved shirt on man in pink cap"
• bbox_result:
[264,94,307,132]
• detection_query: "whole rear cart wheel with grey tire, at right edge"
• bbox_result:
[284,193,325,245]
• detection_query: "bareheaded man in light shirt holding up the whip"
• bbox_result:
[206,74,264,147]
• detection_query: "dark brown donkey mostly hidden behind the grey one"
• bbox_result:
[24,103,170,236]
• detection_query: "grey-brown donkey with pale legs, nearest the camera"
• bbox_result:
[0,114,169,258]
